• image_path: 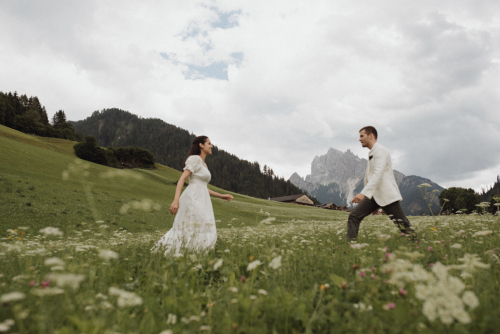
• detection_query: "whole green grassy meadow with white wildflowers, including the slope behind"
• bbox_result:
[0,126,500,334]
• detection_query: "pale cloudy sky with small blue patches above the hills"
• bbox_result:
[0,0,500,189]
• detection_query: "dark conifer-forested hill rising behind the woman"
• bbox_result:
[72,108,317,202]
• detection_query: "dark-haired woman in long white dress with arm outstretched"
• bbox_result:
[152,136,233,255]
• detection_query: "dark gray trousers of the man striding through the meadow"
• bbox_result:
[347,197,417,240]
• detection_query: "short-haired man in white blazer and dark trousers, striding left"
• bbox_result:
[347,126,417,240]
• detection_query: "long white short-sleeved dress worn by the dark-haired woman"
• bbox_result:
[152,155,217,255]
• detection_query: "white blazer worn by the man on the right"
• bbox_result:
[361,143,403,207]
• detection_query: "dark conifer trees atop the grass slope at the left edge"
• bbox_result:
[0,92,83,141]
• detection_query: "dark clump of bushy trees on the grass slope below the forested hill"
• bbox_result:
[73,136,155,168]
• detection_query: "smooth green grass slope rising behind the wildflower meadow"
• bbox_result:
[0,126,345,237]
